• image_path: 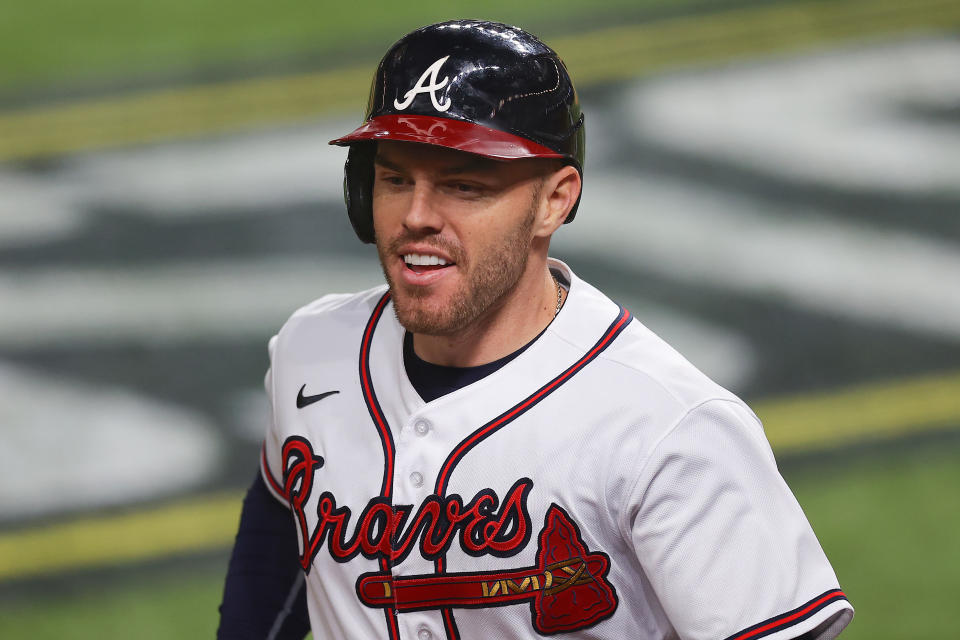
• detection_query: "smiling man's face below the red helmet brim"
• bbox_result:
[373,142,544,336]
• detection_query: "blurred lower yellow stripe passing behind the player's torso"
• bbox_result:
[0,372,960,581]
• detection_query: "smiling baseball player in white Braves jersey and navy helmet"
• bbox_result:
[219,20,853,640]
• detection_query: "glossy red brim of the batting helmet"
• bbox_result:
[330,114,565,160]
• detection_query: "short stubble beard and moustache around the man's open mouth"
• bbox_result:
[377,198,537,336]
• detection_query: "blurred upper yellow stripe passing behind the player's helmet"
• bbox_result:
[0,0,960,161]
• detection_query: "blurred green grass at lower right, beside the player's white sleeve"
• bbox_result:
[786,442,960,640]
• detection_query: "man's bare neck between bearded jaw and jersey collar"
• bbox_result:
[413,263,557,367]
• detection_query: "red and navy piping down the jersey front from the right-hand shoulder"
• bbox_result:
[434,307,632,640]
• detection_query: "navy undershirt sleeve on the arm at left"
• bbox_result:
[217,473,310,640]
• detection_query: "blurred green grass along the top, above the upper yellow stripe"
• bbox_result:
[0,0,730,93]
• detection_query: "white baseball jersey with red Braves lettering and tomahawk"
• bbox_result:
[262,260,853,640]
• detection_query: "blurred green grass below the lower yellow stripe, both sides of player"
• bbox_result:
[0,442,960,640]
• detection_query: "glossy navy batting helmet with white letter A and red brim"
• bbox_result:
[330,20,584,242]
